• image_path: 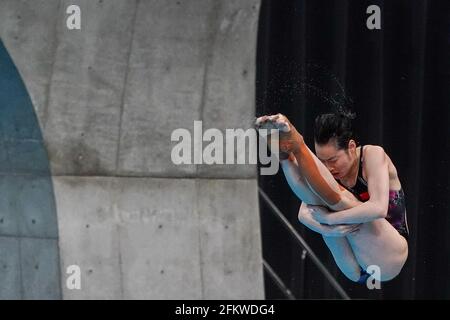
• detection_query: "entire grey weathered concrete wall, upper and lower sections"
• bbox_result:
[0,0,264,299]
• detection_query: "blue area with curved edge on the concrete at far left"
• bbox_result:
[0,40,61,299]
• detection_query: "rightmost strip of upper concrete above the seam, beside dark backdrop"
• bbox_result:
[198,0,259,177]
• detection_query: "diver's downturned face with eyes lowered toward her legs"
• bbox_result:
[315,139,356,179]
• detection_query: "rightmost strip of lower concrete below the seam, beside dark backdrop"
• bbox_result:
[197,179,264,300]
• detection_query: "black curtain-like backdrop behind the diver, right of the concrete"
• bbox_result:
[256,0,450,299]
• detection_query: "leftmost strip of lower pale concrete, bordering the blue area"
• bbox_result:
[54,177,122,299]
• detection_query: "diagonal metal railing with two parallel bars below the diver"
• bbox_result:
[258,187,350,300]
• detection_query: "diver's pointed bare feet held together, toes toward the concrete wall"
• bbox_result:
[255,113,303,158]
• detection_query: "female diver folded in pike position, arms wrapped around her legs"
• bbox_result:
[256,112,408,283]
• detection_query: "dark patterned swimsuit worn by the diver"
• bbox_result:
[337,146,409,240]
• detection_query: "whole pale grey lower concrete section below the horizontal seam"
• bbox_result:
[54,177,263,299]
